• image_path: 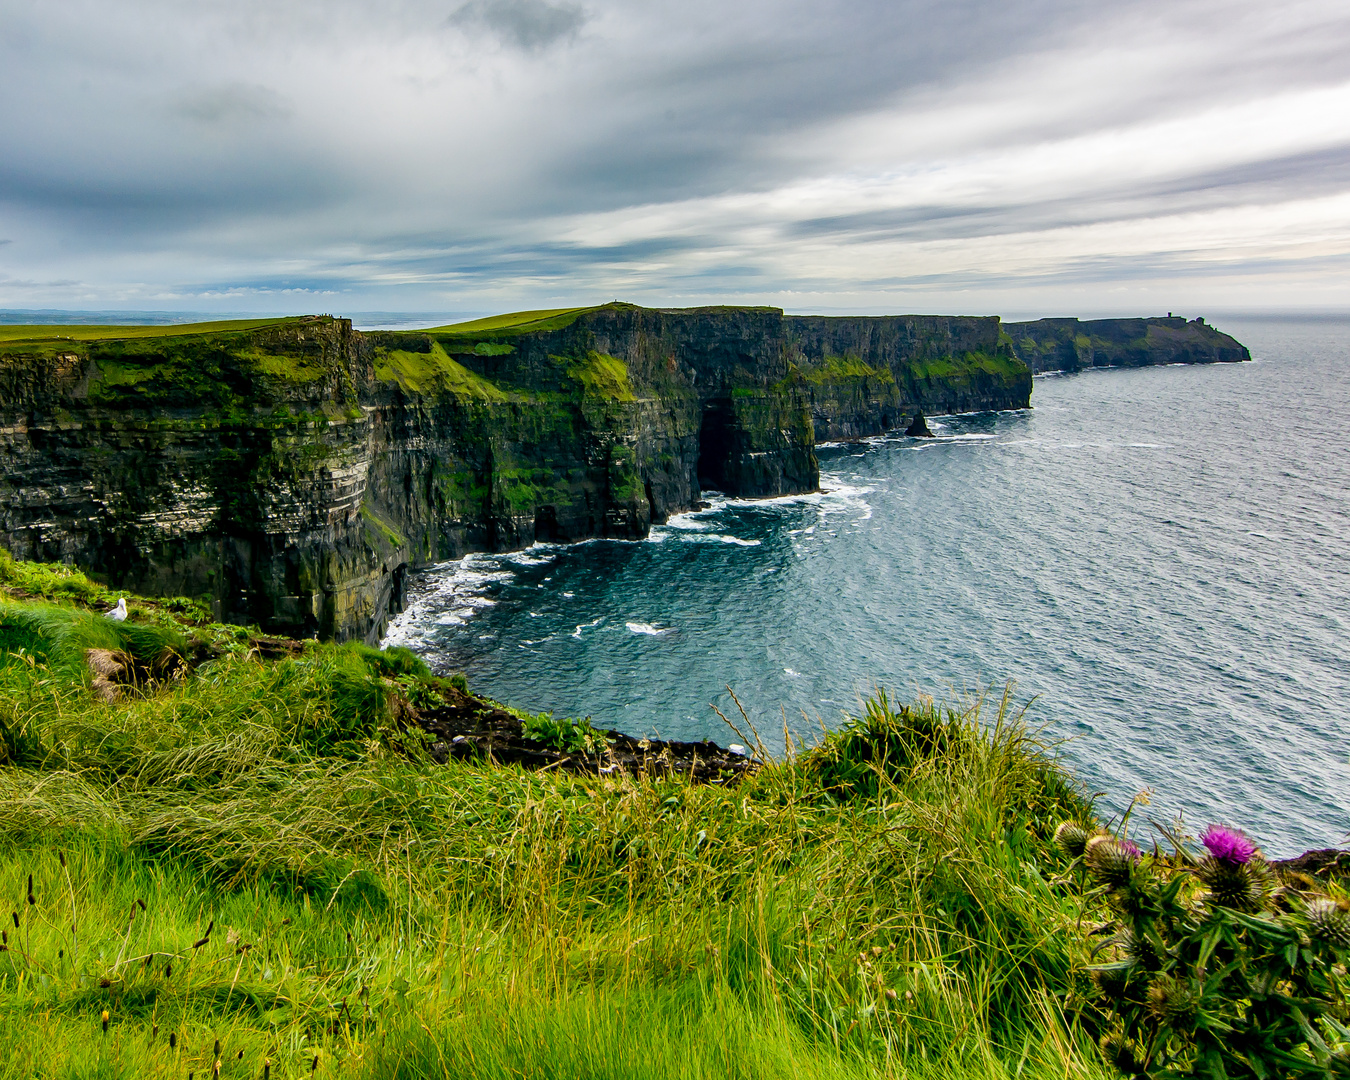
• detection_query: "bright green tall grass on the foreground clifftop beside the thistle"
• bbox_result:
[0,559,1106,1080]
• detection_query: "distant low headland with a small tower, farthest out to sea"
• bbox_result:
[1003,316,1251,375]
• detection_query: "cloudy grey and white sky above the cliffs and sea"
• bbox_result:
[0,0,1350,317]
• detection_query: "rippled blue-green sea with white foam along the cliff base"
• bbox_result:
[389,319,1350,855]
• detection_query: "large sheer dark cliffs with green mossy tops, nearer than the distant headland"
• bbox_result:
[0,304,1030,639]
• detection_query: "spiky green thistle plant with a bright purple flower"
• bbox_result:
[1054,824,1350,1080]
